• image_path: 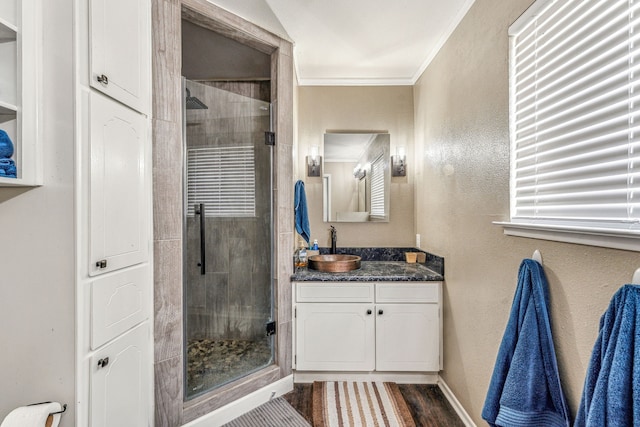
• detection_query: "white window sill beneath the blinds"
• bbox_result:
[493,221,640,252]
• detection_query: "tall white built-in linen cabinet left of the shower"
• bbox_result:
[75,0,154,427]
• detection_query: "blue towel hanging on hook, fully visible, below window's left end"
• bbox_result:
[482,259,570,427]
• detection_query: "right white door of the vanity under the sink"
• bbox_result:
[376,304,440,372]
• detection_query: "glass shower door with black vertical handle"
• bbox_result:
[183,79,274,399]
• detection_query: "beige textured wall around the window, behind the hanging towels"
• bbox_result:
[414,0,640,425]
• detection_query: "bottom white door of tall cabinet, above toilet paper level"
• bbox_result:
[90,322,152,427]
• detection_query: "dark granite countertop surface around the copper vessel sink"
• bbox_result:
[291,261,444,282]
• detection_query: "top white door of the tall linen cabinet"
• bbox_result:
[89,0,151,114]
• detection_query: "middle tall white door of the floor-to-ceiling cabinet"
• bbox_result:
[89,92,150,276]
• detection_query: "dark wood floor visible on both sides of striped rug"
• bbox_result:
[284,383,464,427]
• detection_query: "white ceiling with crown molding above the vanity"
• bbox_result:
[210,0,474,85]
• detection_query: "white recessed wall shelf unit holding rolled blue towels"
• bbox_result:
[0,0,42,187]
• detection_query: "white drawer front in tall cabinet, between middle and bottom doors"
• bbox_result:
[91,265,152,350]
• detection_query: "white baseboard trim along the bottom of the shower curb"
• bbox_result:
[183,375,293,427]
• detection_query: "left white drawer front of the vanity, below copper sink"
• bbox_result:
[296,282,374,302]
